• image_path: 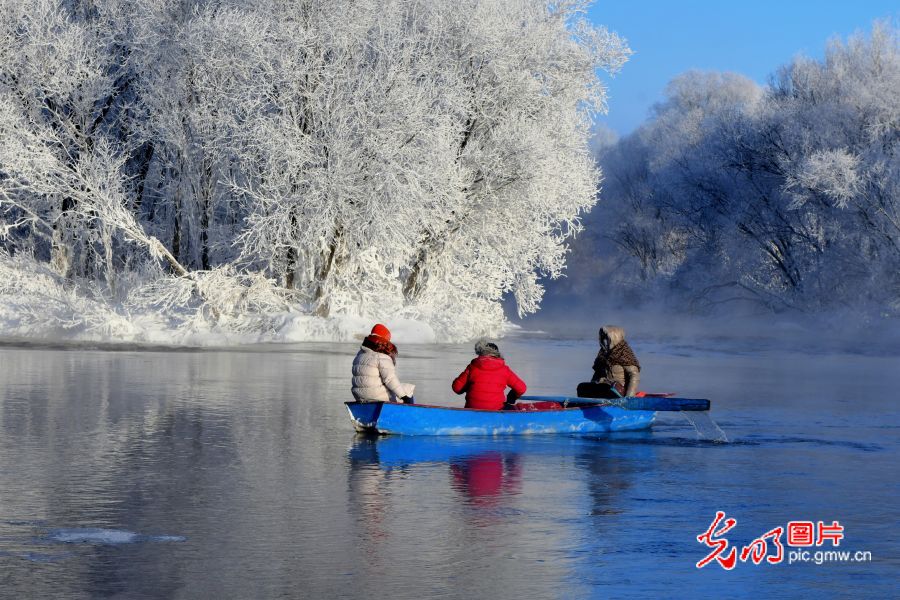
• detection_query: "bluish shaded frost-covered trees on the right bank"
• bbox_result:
[578,23,900,314]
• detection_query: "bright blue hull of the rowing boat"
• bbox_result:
[345,402,656,435]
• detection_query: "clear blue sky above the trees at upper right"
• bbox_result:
[588,0,900,134]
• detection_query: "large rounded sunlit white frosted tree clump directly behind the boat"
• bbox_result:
[229,0,626,328]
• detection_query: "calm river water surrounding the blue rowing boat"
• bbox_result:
[0,338,900,600]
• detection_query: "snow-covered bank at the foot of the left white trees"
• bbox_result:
[0,257,446,346]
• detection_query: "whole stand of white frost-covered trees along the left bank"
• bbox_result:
[0,0,630,336]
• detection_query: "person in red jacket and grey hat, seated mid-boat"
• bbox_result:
[453,340,526,410]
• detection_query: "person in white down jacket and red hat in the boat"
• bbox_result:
[350,323,416,404]
